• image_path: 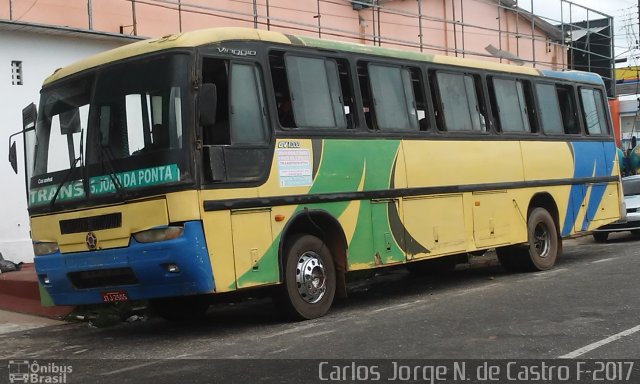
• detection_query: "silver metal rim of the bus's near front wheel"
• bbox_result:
[296,251,327,304]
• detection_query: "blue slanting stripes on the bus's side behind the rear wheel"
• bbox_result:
[562,141,616,236]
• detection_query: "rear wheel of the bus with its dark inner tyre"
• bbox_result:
[496,208,562,272]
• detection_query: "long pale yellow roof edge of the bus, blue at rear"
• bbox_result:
[44,27,603,85]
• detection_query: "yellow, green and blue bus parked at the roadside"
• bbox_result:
[10,28,624,319]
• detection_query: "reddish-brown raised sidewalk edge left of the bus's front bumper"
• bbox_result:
[0,264,73,324]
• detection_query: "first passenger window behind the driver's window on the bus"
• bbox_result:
[279,55,347,128]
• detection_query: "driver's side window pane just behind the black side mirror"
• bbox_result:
[229,63,269,144]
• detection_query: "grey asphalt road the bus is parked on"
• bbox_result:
[0,234,640,383]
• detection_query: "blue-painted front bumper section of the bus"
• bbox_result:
[35,221,215,305]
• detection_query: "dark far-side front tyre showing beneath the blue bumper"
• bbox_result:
[149,296,209,322]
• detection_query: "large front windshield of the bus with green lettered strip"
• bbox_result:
[27,54,191,207]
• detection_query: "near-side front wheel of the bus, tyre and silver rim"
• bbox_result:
[276,234,336,320]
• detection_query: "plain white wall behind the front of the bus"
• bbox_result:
[0,31,129,262]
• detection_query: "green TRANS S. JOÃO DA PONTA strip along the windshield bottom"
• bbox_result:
[29,164,180,206]
